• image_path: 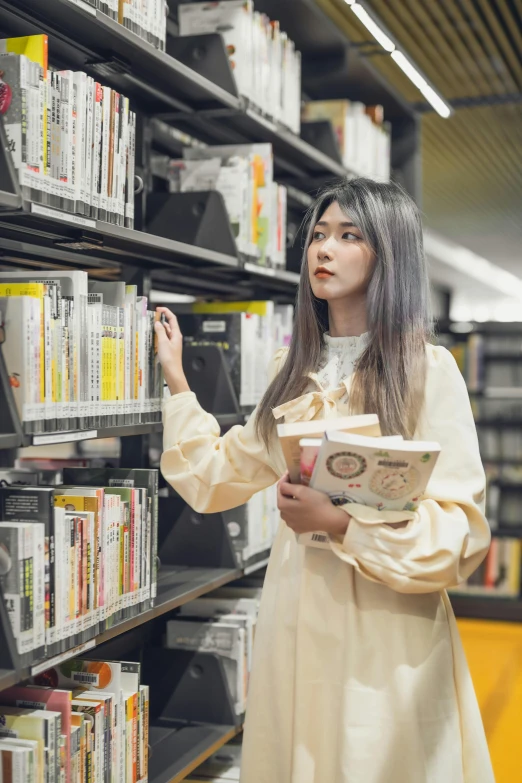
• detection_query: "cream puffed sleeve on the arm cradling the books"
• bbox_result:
[331,345,491,593]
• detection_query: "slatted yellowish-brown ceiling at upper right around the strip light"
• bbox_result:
[316,0,522,277]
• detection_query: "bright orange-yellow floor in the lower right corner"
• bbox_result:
[459,620,522,783]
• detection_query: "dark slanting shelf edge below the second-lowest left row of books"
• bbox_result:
[0,569,243,691]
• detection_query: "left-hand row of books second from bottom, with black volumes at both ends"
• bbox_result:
[0,468,158,661]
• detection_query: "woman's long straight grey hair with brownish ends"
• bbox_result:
[256,177,431,446]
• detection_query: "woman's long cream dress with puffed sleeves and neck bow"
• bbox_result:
[161,335,494,783]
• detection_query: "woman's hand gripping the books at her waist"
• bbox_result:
[277,473,350,536]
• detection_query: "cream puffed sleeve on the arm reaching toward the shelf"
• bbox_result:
[161,349,287,514]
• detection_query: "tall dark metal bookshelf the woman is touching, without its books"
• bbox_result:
[0,0,420,783]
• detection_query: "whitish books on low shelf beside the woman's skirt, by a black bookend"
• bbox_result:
[165,587,260,715]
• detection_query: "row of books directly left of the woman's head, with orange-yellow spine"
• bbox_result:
[162,144,287,268]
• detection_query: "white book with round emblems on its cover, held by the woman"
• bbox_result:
[298,430,440,548]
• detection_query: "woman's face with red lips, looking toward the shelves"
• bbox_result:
[308,201,375,301]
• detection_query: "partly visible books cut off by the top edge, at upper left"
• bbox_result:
[69,0,168,50]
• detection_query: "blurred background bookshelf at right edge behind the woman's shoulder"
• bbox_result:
[438,322,522,622]
